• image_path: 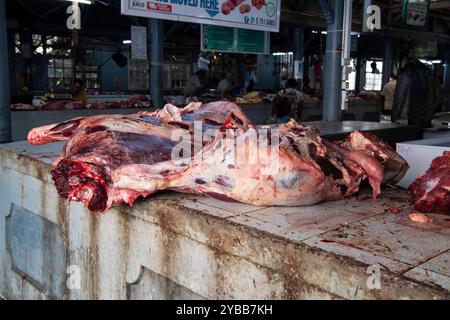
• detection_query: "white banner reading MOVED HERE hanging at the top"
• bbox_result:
[121,0,281,32]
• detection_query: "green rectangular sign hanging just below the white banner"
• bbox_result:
[201,25,270,54]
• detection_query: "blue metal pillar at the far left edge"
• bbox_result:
[0,0,11,143]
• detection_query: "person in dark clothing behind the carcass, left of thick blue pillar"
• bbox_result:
[272,79,305,123]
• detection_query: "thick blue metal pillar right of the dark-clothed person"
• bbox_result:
[323,0,344,121]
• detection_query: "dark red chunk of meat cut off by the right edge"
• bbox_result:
[409,151,450,214]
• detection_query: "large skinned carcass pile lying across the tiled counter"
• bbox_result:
[28,102,407,212]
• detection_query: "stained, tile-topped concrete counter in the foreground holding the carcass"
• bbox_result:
[0,142,450,299]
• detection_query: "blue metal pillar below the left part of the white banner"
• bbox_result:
[148,19,164,108]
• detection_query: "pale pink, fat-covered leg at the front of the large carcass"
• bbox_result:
[115,125,343,206]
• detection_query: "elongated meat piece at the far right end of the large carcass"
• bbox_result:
[341,131,409,184]
